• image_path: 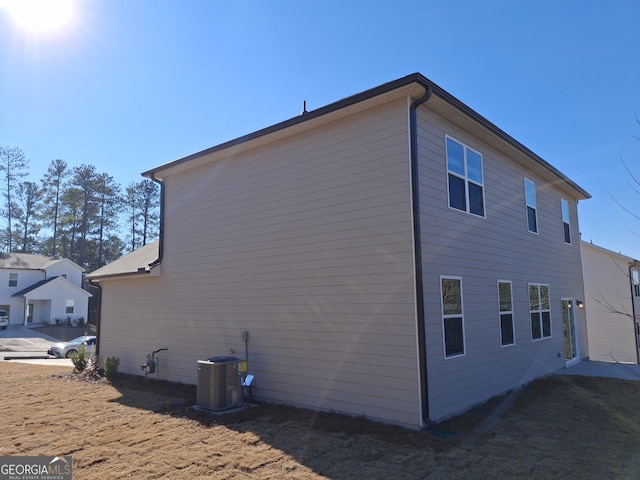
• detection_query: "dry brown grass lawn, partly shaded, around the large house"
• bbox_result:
[0,362,640,480]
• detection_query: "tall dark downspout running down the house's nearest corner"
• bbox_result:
[409,85,433,424]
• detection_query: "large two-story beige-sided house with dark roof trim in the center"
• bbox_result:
[89,74,589,428]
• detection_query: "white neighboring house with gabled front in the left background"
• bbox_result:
[0,253,91,325]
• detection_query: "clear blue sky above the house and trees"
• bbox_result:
[0,0,640,258]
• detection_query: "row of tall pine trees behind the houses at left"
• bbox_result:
[0,146,160,272]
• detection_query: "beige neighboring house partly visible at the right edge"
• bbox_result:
[582,242,640,364]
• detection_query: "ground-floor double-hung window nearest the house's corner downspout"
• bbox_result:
[440,277,464,357]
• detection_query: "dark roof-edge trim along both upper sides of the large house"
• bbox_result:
[142,73,591,198]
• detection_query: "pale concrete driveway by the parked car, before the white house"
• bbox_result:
[0,325,73,366]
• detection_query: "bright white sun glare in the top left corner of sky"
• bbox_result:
[0,0,73,33]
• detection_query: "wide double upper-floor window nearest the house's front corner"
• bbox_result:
[447,137,484,217]
